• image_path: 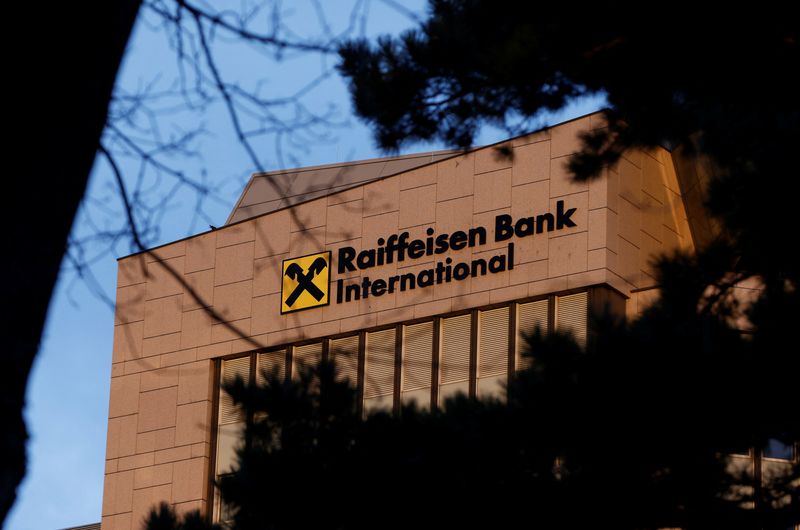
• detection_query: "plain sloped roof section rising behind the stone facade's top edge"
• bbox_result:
[225,151,458,225]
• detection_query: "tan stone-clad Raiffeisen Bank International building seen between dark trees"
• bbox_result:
[102,109,786,530]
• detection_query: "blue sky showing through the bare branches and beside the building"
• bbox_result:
[5,0,603,530]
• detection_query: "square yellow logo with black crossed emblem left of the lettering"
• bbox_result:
[281,252,331,314]
